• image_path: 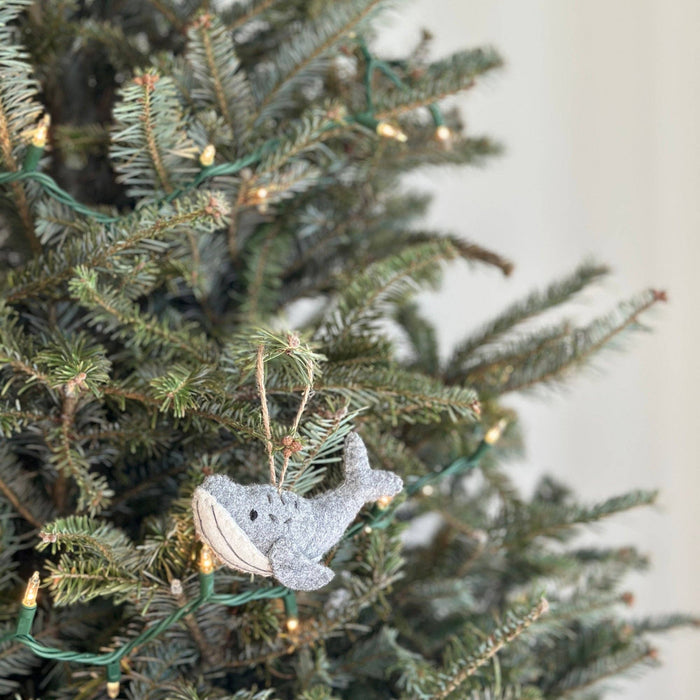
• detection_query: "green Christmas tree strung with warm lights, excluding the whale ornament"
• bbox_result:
[0,0,695,700]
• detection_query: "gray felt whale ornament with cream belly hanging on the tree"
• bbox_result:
[192,433,403,591]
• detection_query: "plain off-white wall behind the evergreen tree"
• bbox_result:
[382,0,700,700]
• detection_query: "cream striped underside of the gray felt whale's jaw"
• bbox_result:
[193,487,272,576]
